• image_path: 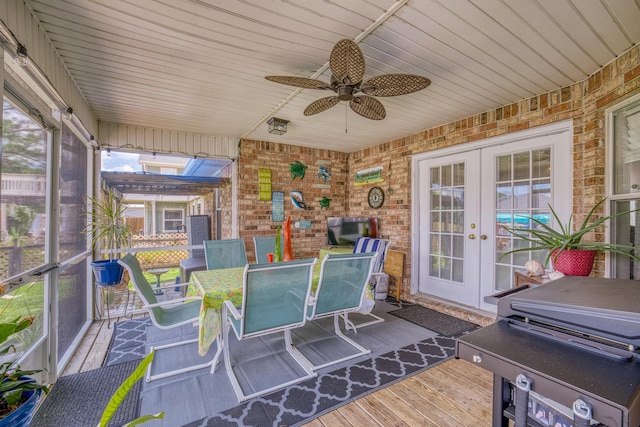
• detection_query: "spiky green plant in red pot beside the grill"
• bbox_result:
[501,198,640,276]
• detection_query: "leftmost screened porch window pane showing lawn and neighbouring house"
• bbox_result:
[0,99,49,351]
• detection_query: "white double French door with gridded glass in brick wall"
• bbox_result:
[413,122,572,311]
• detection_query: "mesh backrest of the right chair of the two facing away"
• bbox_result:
[309,252,379,318]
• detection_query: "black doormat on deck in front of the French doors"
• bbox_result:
[389,305,479,337]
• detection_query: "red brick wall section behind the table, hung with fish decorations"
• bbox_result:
[238,140,348,262]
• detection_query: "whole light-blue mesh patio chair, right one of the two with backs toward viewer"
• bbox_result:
[307,252,379,370]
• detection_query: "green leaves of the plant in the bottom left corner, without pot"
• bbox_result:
[0,317,49,418]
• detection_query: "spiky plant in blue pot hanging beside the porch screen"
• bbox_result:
[85,189,131,286]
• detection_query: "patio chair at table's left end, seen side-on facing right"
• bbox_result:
[118,253,214,381]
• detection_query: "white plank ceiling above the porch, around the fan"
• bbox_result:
[26,0,640,152]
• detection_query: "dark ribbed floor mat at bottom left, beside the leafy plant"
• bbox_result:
[29,360,141,427]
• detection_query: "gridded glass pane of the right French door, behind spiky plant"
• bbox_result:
[495,148,551,290]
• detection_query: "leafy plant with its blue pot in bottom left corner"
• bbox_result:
[0,317,49,427]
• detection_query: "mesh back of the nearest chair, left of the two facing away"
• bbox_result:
[232,258,317,337]
